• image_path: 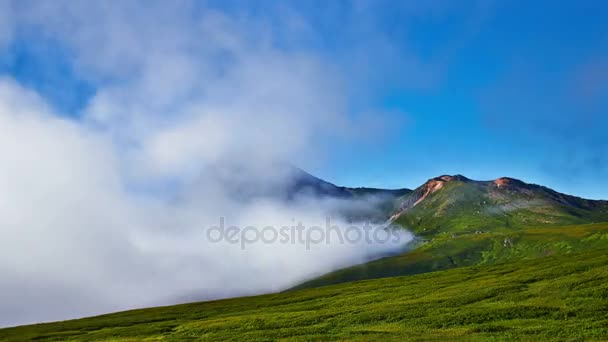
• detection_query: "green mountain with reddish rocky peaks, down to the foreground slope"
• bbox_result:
[296,175,608,288]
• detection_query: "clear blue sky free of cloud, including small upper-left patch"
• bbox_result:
[0,1,608,199]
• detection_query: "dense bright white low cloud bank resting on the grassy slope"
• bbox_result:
[0,80,409,325]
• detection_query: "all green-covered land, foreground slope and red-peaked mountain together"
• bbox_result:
[0,176,608,341]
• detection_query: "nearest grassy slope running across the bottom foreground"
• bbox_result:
[0,249,608,341]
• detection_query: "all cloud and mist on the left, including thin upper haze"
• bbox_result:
[0,1,411,326]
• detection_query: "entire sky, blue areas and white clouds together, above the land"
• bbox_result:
[0,0,608,326]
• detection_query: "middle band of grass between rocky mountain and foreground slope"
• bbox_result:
[296,223,608,289]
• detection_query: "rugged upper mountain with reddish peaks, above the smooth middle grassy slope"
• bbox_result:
[391,175,608,236]
